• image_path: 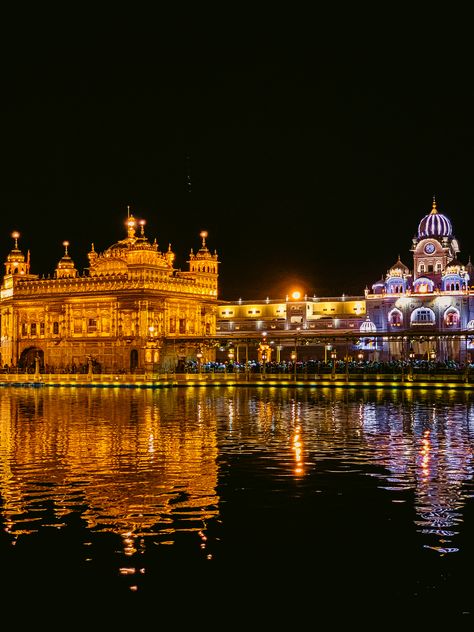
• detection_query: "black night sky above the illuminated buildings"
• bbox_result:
[0,21,474,300]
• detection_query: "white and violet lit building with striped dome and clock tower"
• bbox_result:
[365,199,474,362]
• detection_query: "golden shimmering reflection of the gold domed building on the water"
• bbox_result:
[0,388,219,557]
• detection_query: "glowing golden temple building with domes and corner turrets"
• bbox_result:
[0,213,219,373]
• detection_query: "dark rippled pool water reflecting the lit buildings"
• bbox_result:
[0,387,474,620]
